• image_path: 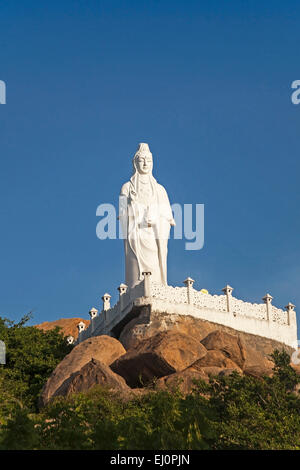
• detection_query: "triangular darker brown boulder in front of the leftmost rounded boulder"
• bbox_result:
[53,359,131,398]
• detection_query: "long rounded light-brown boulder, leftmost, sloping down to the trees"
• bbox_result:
[39,335,125,406]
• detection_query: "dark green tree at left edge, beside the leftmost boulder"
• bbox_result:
[0,315,72,414]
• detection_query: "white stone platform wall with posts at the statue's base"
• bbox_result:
[77,273,297,349]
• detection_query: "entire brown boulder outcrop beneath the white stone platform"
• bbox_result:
[40,309,292,400]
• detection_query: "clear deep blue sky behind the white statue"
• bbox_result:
[0,0,300,323]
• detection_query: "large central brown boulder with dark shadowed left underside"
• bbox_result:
[110,331,206,387]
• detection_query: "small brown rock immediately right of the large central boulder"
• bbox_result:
[201,330,246,369]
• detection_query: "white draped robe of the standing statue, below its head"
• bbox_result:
[119,172,175,287]
